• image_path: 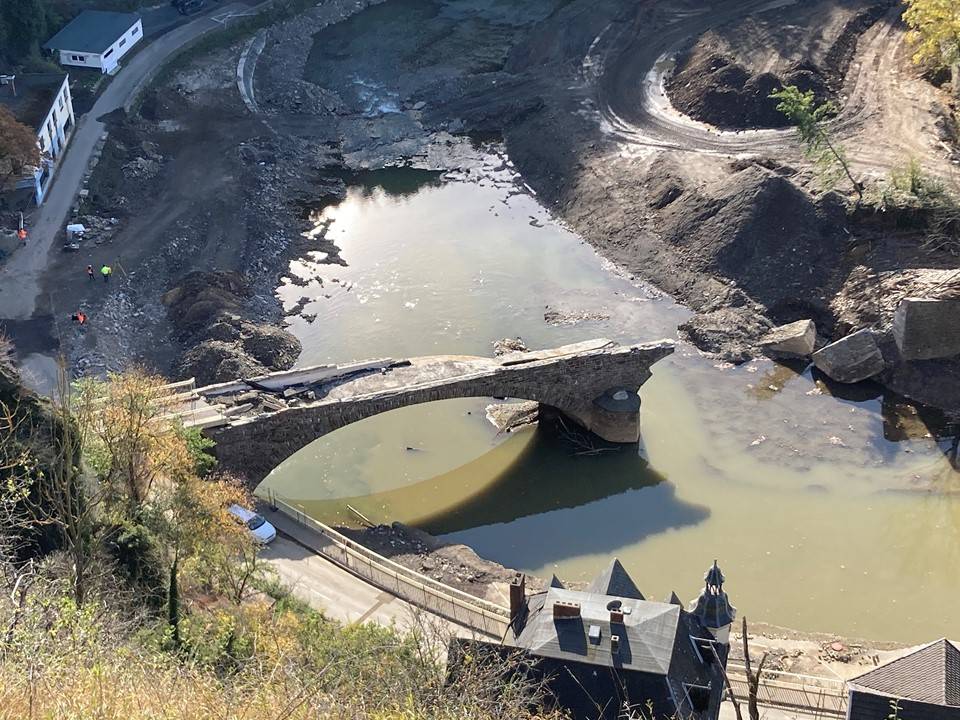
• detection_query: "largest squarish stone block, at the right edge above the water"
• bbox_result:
[893,298,960,360]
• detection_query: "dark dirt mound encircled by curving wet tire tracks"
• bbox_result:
[666,3,888,129]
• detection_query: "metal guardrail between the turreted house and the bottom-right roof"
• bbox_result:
[727,664,847,718]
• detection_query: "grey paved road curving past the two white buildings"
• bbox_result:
[0,2,250,320]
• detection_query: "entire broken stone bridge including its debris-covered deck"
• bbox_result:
[171,339,674,484]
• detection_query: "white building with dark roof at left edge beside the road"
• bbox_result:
[0,73,76,205]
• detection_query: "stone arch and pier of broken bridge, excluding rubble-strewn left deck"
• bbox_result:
[205,342,673,486]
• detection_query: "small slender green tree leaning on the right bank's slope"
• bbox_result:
[770,85,864,207]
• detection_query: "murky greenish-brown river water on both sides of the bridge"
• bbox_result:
[263,156,960,642]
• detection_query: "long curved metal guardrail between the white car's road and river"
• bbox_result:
[269,496,510,639]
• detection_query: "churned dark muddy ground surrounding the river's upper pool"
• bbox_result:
[24,0,960,409]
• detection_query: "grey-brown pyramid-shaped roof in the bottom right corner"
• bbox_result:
[850,639,960,707]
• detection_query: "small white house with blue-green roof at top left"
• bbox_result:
[43,10,143,74]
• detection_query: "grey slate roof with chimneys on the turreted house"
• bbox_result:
[516,588,689,675]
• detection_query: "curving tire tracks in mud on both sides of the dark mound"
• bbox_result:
[582,0,950,173]
